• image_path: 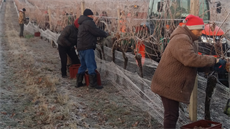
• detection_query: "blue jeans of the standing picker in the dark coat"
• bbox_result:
[78,49,97,74]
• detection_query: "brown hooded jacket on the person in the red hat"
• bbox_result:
[151,26,216,104]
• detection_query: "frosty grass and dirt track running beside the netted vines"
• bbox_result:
[0,0,162,129]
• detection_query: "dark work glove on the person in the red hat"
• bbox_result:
[213,58,226,73]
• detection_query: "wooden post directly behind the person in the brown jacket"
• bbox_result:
[189,0,199,121]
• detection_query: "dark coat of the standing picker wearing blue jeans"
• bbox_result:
[77,15,108,51]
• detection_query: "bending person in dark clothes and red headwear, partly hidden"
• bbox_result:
[57,19,80,78]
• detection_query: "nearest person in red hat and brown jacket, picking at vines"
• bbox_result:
[151,15,226,129]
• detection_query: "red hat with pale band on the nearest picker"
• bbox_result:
[184,15,204,30]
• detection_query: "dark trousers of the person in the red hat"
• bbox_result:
[161,96,179,129]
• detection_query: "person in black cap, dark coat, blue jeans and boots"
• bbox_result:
[76,9,108,89]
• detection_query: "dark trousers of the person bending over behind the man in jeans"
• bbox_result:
[58,45,80,75]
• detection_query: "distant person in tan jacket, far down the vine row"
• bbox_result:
[18,8,26,38]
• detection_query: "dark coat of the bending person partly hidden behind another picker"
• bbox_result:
[57,25,78,47]
